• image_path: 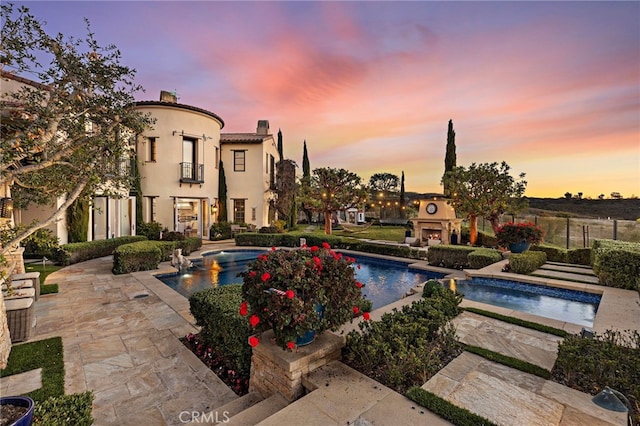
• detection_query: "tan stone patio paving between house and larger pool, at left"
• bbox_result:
[32,251,237,425]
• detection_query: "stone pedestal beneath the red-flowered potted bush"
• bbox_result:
[249,331,345,402]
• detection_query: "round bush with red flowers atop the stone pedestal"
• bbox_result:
[238,243,370,350]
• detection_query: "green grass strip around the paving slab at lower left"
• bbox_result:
[0,337,64,402]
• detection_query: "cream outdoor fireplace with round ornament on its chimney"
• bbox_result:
[411,196,462,246]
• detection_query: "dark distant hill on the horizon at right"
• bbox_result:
[527,198,640,220]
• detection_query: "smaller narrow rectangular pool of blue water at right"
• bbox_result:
[445,277,601,327]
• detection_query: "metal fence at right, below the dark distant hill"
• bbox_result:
[478,215,640,248]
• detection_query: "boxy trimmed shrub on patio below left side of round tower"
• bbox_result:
[111,241,160,275]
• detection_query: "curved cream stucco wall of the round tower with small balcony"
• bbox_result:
[136,102,223,237]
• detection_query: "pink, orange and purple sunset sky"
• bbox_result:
[10,1,640,198]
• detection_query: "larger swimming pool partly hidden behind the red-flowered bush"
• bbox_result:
[156,250,444,309]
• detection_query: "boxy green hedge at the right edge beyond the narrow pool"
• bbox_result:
[591,240,640,291]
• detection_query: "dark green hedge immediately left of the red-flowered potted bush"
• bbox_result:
[189,284,252,375]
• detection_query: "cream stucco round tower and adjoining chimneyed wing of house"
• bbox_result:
[135,91,278,238]
